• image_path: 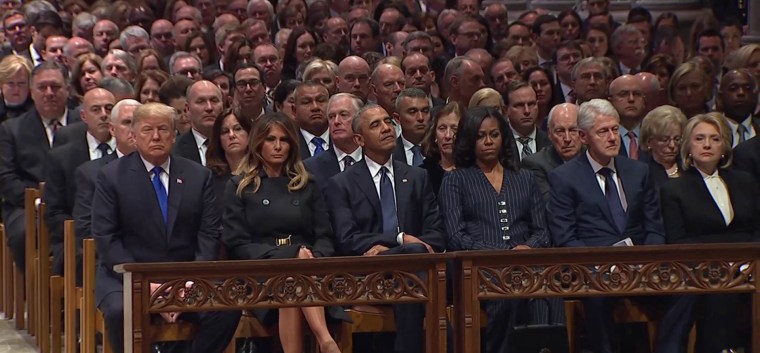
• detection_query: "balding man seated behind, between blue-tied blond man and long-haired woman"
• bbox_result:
[174,80,224,165]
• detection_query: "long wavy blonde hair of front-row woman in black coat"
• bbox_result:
[235,112,309,197]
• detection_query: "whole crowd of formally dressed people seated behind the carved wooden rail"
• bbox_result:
[0,0,760,353]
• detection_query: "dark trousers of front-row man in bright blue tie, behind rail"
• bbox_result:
[100,292,241,353]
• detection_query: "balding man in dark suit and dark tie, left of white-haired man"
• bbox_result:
[43,88,116,275]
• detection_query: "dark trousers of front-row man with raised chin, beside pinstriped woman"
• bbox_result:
[381,244,427,353]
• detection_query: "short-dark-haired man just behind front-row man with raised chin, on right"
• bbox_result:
[392,88,430,167]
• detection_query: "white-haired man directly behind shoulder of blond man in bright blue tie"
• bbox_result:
[71,99,142,285]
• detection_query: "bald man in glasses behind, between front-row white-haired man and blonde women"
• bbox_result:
[609,75,646,159]
